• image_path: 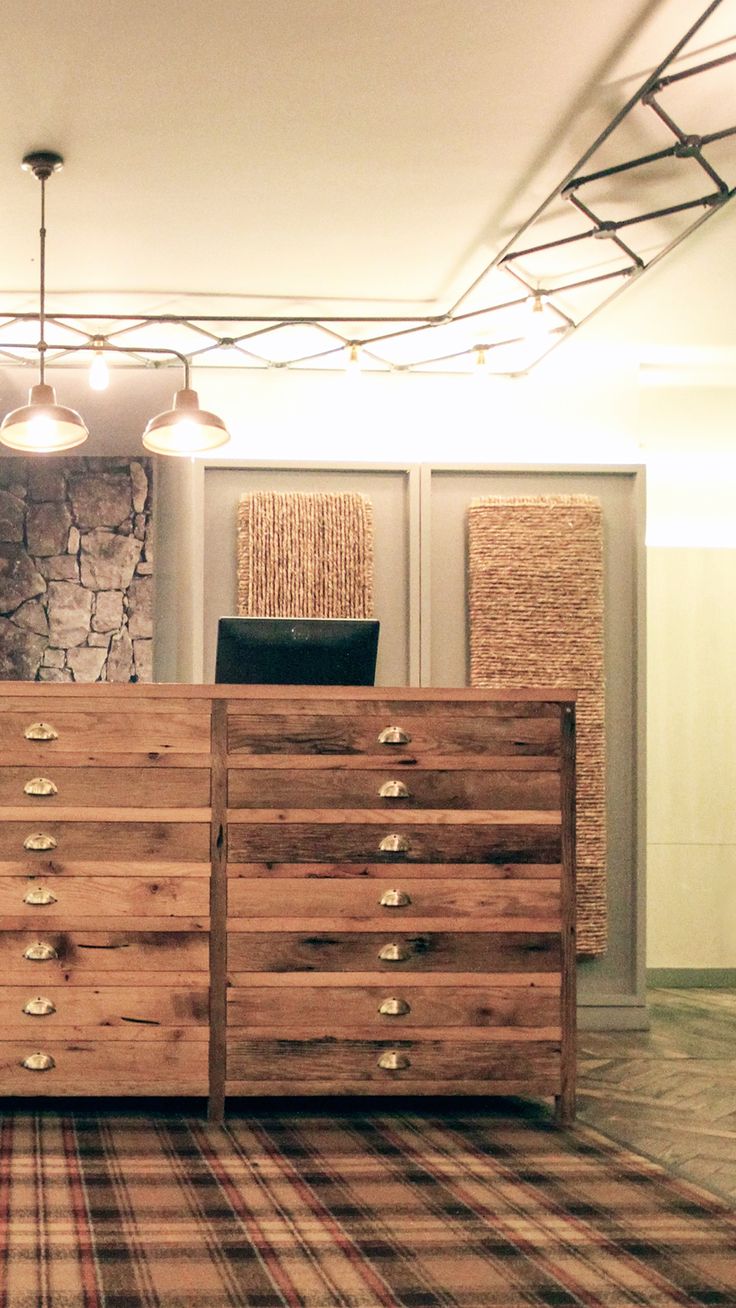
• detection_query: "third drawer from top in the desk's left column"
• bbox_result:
[0,810,209,872]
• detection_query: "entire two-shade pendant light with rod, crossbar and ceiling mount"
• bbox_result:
[0,150,230,455]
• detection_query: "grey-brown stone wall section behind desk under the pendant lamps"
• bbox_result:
[0,455,153,681]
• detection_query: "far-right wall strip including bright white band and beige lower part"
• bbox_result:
[641,384,736,969]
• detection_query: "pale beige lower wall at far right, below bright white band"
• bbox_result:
[647,548,736,968]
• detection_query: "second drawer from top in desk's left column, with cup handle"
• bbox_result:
[0,759,209,815]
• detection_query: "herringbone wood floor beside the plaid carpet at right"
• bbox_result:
[578,990,736,1201]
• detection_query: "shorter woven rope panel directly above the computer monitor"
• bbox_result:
[238,491,373,617]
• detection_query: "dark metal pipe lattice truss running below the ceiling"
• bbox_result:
[0,0,736,375]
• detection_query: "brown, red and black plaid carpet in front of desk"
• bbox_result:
[0,1101,736,1308]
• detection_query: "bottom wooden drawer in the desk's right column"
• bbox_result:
[227,1037,560,1095]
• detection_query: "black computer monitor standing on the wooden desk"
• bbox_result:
[214,617,380,685]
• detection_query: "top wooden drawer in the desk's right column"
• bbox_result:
[227,709,560,760]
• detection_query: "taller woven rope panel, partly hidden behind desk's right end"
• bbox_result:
[468,496,607,955]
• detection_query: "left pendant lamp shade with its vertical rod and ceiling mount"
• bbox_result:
[0,150,89,454]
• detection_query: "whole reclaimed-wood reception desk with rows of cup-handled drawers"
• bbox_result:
[0,683,575,1121]
